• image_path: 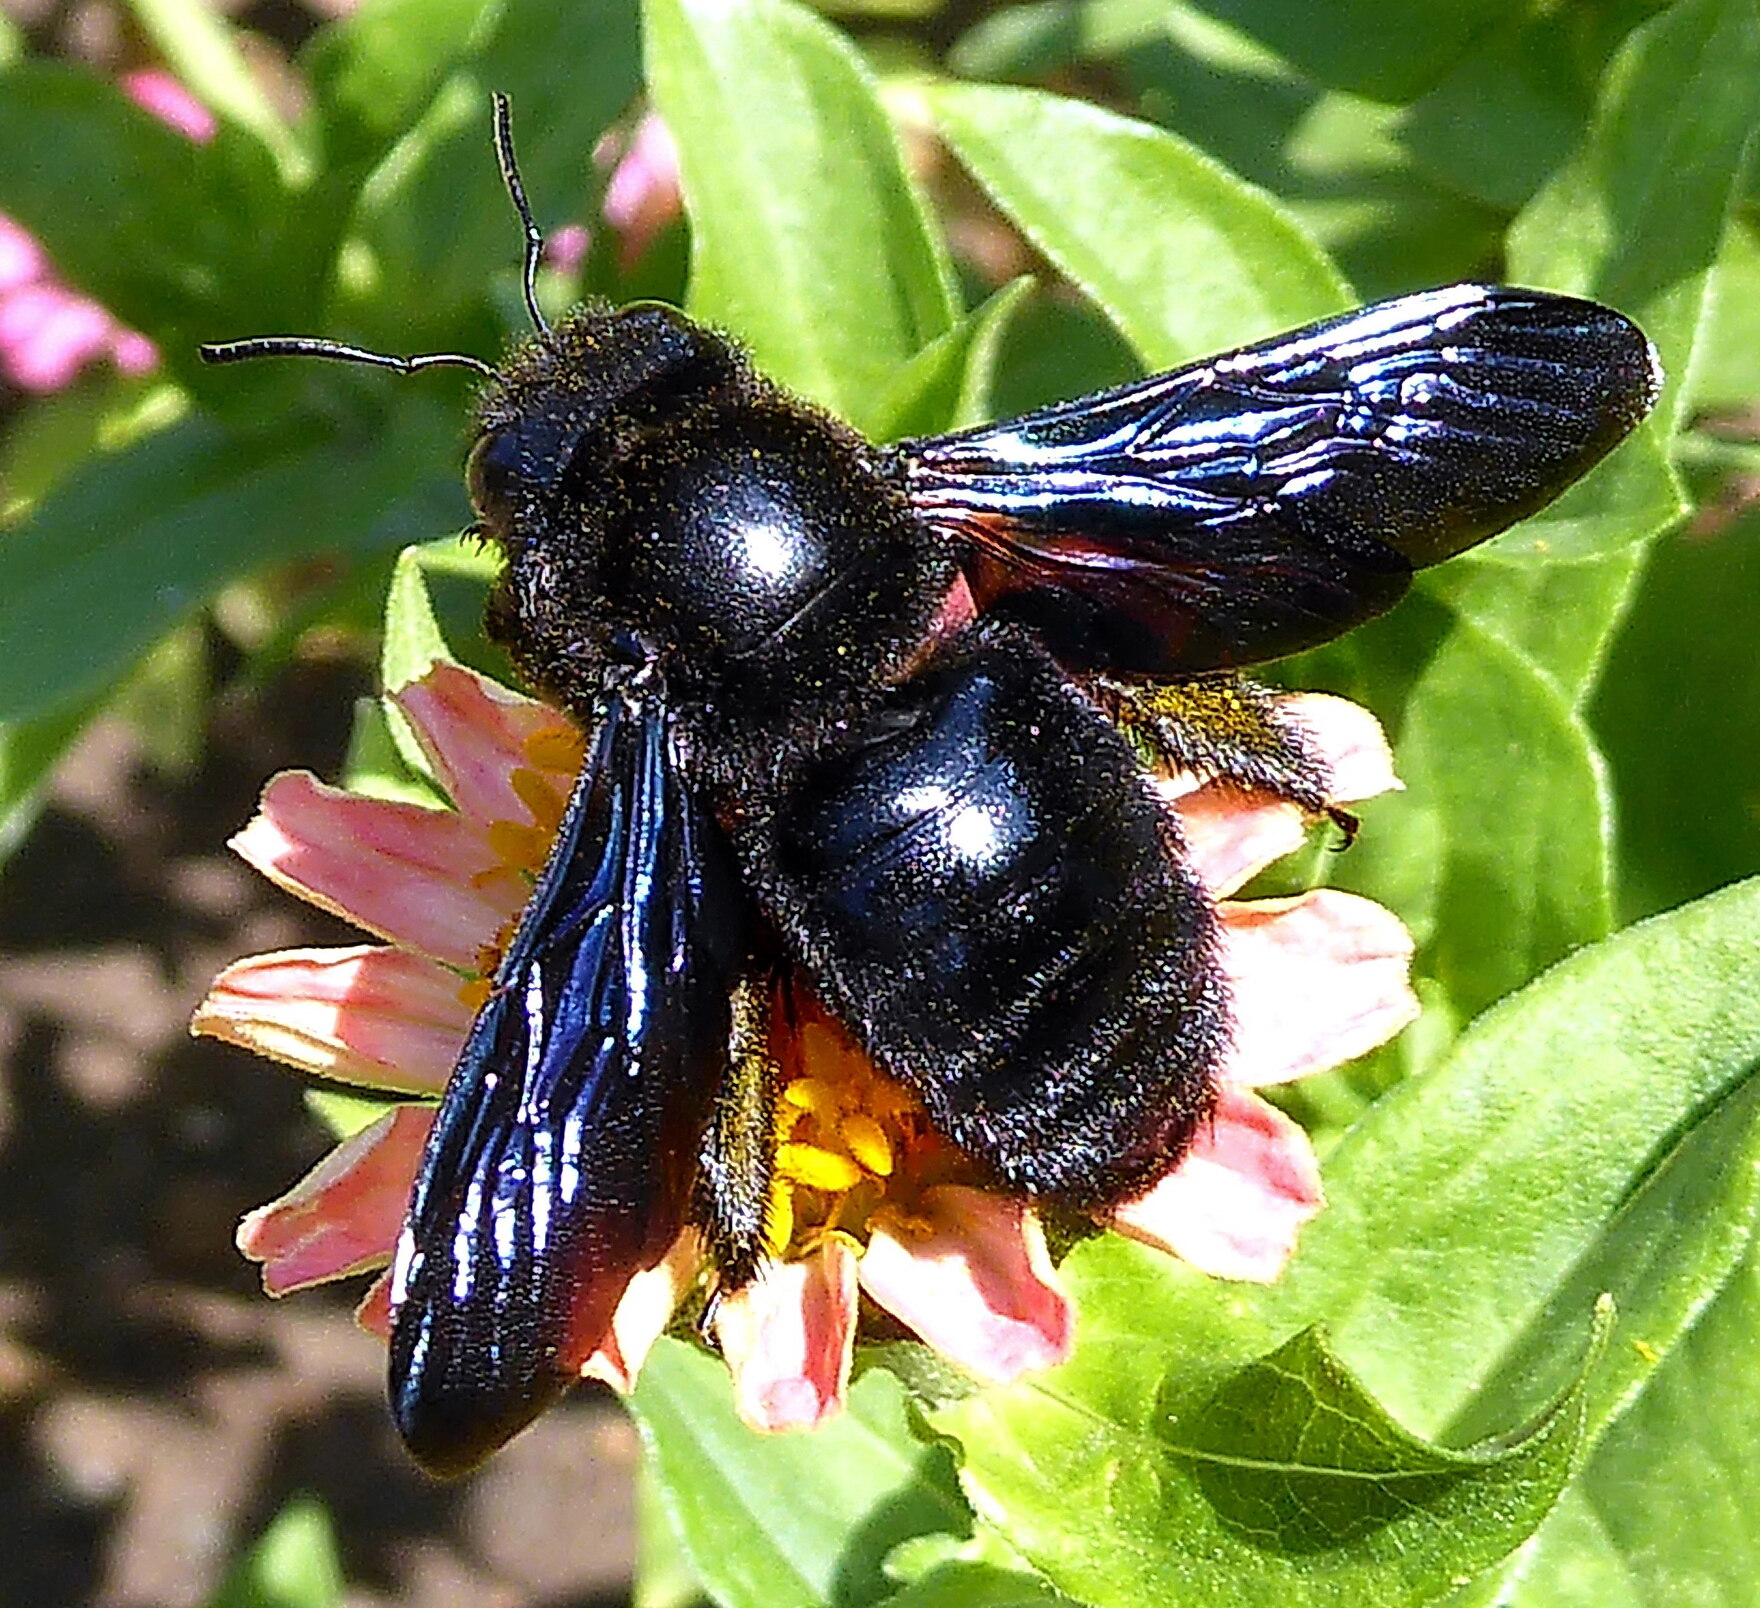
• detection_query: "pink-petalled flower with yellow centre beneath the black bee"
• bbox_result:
[192,663,1417,1429]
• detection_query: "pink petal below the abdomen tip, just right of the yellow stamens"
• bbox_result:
[861,1184,1072,1383]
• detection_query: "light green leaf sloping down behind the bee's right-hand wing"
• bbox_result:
[929,84,1350,368]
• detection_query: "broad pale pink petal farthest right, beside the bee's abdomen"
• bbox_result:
[1221,888,1419,1087]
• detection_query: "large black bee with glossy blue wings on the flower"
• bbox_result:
[202,100,1658,1474]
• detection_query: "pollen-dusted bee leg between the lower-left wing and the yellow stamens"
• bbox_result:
[693,968,781,1301]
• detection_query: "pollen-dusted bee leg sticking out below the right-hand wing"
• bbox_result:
[1089,674,1353,819]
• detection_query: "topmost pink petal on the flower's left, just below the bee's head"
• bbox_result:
[392,663,574,822]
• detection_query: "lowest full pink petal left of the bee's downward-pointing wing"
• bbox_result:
[238,1105,435,1295]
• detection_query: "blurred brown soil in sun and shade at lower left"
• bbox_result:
[0,665,635,1608]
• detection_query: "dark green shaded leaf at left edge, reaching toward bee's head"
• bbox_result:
[0,391,463,720]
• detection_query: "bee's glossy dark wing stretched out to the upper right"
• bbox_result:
[898,285,1660,676]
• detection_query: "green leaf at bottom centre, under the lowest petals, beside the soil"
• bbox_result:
[632,1341,972,1608]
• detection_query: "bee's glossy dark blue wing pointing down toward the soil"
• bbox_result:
[391,675,744,1474]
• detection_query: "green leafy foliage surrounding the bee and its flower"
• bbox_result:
[0,0,1760,1608]
